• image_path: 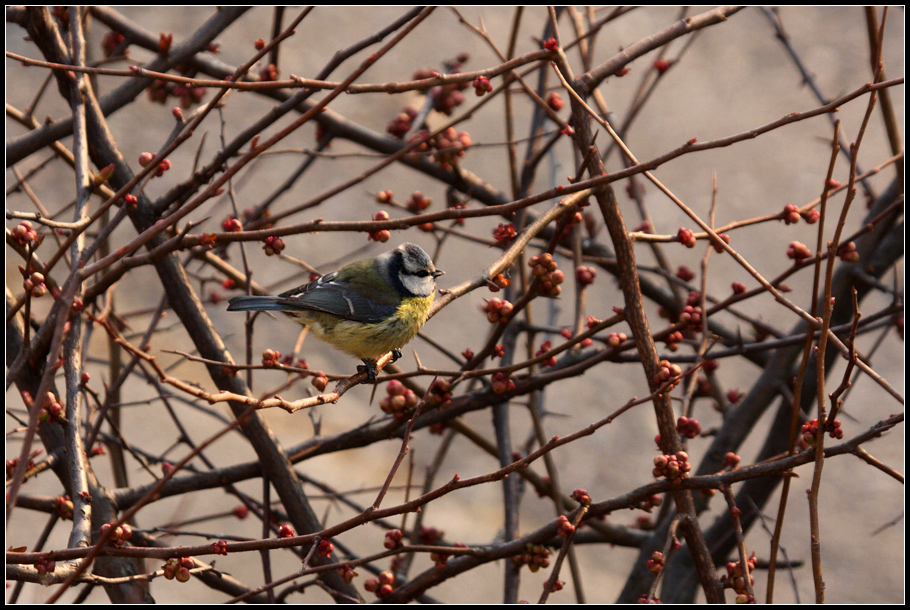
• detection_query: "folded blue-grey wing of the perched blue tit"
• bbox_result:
[276,273,397,324]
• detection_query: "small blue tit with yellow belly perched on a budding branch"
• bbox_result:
[228,243,445,382]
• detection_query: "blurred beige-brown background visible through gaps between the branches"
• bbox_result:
[6,7,904,603]
